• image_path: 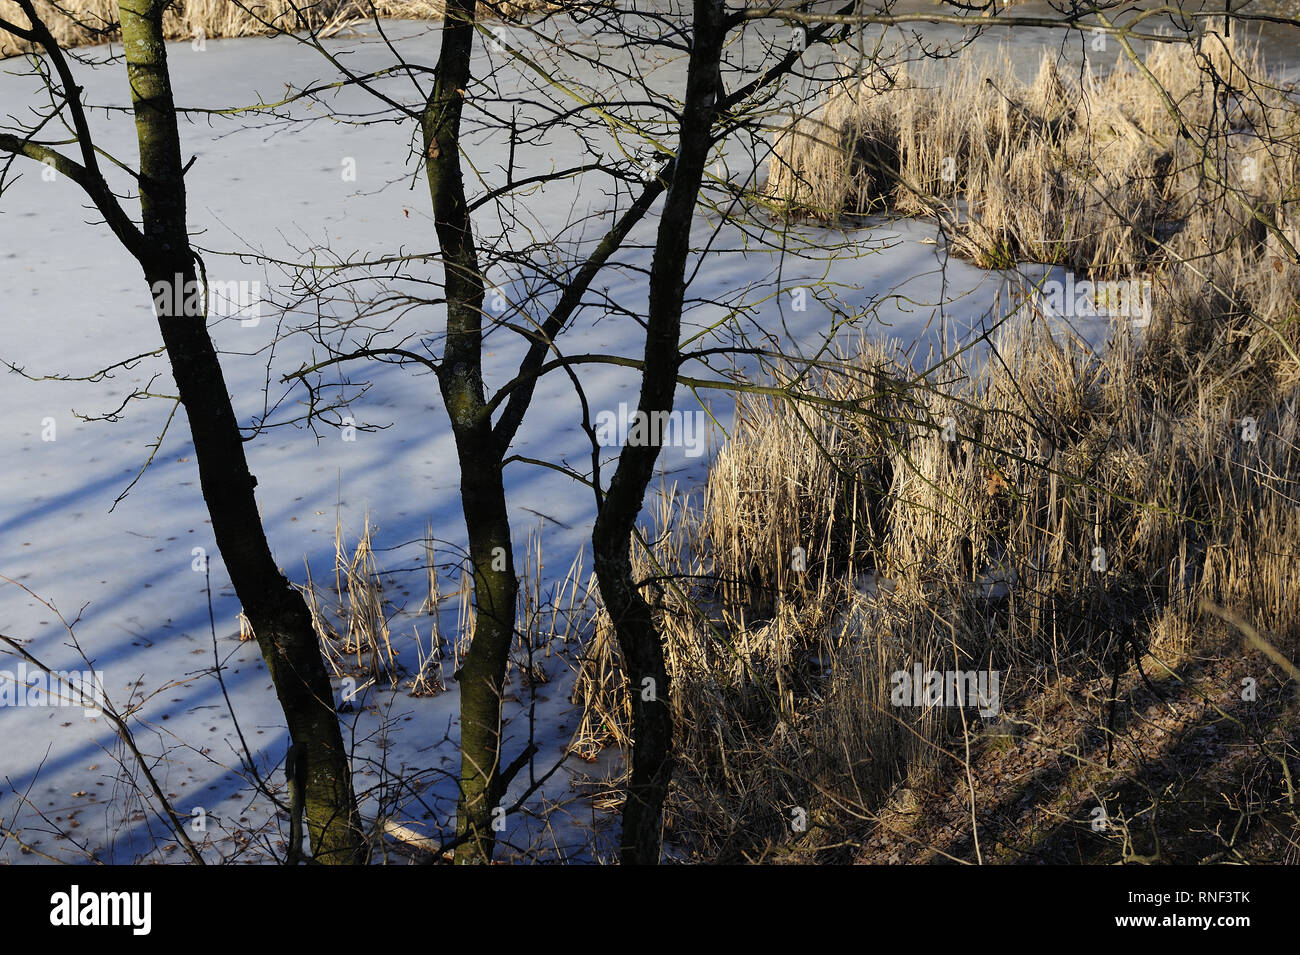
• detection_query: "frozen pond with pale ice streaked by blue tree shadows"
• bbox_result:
[0,8,1294,861]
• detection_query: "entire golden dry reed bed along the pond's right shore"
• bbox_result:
[577,29,1300,860]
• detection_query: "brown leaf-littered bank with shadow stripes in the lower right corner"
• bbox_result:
[854,633,1300,864]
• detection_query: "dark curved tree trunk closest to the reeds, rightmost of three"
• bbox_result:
[592,0,725,864]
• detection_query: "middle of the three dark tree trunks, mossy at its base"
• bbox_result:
[423,0,519,864]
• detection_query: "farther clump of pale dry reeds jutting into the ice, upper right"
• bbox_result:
[766,27,1300,274]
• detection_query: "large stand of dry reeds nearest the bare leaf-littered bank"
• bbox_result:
[577,249,1300,859]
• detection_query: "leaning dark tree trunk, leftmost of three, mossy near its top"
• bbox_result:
[120,0,367,864]
